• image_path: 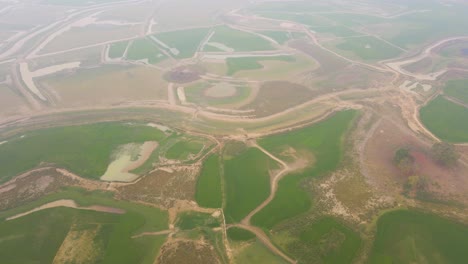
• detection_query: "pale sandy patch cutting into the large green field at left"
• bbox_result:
[101,141,158,182]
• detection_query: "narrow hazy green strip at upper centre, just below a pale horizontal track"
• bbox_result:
[226,56,296,75]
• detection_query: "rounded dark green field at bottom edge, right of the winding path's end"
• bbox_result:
[286,217,362,264]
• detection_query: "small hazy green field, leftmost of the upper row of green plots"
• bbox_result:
[127,38,167,64]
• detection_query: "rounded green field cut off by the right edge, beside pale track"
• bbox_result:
[420,96,468,142]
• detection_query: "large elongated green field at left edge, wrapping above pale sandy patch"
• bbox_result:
[0,123,166,182]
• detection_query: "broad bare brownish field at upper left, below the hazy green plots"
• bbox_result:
[40,65,167,108]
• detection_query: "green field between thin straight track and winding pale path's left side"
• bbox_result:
[224,148,277,222]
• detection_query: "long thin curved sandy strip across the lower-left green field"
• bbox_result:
[6,199,125,221]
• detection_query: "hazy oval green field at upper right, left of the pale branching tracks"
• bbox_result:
[335,36,402,61]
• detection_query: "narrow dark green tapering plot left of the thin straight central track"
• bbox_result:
[195,154,223,208]
